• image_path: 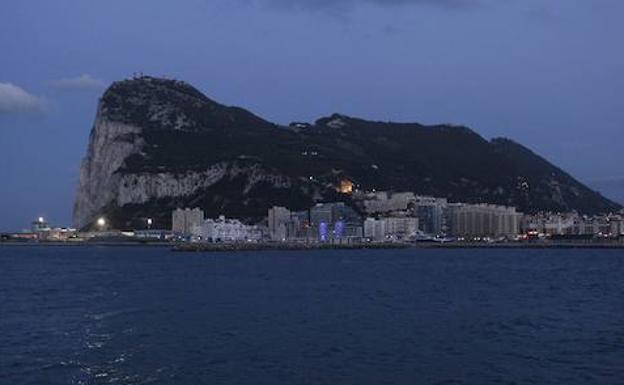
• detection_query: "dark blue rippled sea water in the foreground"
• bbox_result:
[0,247,624,385]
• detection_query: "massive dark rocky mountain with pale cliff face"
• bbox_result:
[74,77,619,228]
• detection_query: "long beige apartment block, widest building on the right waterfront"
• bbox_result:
[448,203,522,237]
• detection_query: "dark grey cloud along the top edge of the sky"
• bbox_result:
[247,0,482,10]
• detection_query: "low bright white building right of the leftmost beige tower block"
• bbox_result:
[201,215,262,242]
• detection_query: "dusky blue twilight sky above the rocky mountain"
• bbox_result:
[0,0,624,231]
